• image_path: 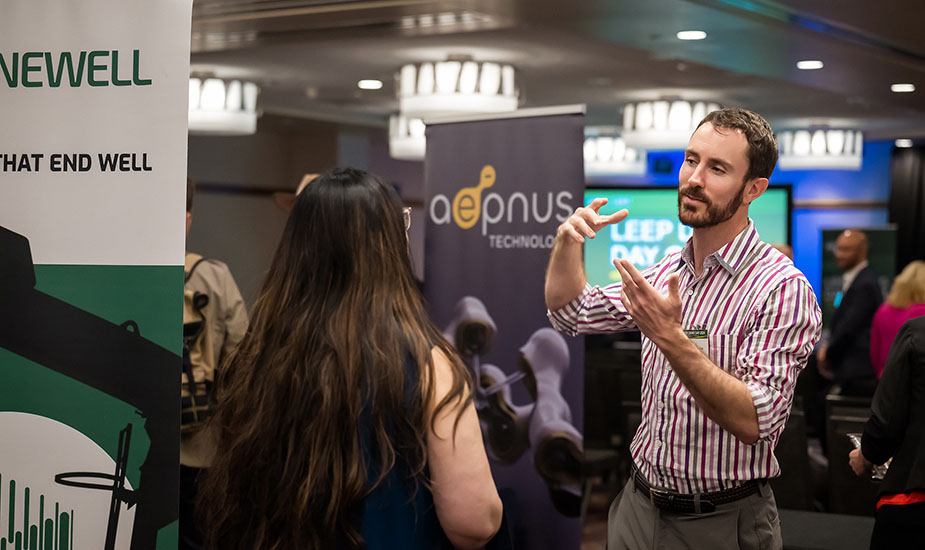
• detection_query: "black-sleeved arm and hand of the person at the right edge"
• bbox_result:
[849,322,916,475]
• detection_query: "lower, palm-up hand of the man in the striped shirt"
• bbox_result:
[613,258,681,345]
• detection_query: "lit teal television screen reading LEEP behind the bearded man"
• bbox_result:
[585,186,790,286]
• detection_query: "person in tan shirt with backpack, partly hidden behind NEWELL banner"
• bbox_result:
[179,179,247,550]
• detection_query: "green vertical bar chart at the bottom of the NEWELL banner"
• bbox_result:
[0,472,74,550]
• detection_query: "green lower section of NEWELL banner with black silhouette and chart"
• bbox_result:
[0,265,183,550]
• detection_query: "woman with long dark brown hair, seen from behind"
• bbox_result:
[199,168,501,550]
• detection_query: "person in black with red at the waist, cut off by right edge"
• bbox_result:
[848,317,925,550]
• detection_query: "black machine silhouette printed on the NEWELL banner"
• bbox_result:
[0,227,180,550]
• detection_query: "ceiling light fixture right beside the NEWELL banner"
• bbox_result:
[189,78,259,136]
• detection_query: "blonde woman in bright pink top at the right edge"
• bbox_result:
[870,260,925,378]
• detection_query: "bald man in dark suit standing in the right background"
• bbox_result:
[817,229,883,396]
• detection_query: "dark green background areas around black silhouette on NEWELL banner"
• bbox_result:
[0,266,183,485]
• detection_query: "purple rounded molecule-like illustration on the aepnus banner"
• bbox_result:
[444,296,583,517]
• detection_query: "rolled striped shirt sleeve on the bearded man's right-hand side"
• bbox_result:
[736,277,822,440]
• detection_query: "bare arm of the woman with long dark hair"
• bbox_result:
[427,348,503,548]
